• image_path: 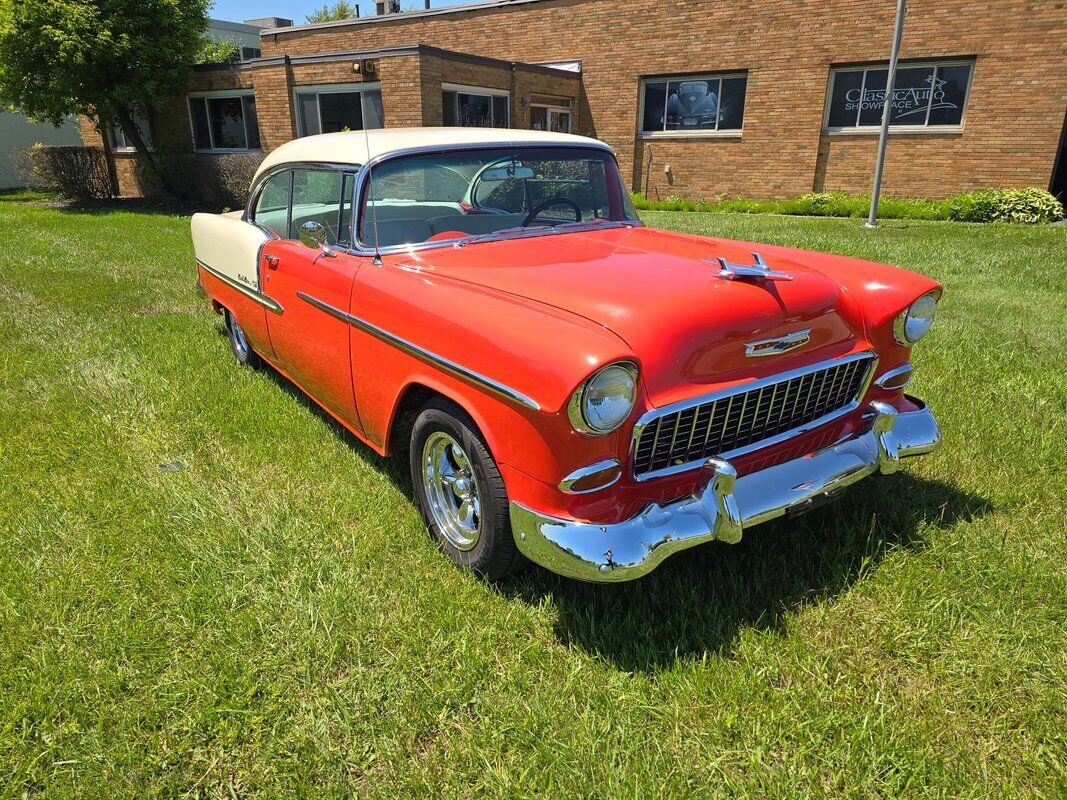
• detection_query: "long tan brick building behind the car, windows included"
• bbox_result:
[83,0,1067,198]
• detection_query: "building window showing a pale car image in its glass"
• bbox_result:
[641,74,748,137]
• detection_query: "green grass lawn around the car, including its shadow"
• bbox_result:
[0,195,1067,798]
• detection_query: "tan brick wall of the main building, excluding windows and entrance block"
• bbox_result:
[256,0,1067,197]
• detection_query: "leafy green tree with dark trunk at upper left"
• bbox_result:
[0,0,209,187]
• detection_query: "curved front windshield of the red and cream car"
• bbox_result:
[360,147,638,247]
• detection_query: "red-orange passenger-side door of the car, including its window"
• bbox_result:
[256,166,362,430]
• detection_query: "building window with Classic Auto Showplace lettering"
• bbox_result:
[825,61,974,131]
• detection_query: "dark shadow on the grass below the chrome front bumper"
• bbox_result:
[500,473,991,672]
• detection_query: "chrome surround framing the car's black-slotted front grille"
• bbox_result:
[628,350,878,482]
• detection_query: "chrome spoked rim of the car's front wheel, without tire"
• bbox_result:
[423,431,481,551]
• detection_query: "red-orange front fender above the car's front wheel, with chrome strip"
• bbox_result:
[351,258,641,483]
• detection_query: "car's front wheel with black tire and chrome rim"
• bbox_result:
[409,400,524,580]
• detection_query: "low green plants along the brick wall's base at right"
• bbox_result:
[633,189,1064,223]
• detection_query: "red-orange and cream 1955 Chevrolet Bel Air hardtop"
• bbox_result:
[192,128,941,581]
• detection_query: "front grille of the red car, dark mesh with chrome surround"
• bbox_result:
[634,354,872,478]
